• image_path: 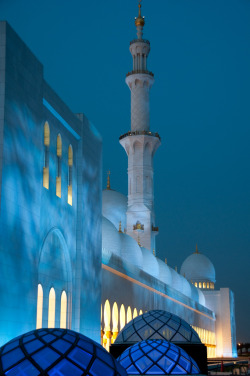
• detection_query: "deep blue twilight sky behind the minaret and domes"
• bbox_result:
[0,0,250,341]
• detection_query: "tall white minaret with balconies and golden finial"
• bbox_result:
[120,1,160,253]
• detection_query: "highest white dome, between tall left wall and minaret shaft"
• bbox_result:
[102,189,128,231]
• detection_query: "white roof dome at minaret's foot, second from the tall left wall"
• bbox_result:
[118,233,143,269]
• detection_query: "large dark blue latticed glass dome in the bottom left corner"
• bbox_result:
[0,329,127,376]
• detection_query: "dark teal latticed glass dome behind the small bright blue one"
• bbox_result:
[115,310,201,344]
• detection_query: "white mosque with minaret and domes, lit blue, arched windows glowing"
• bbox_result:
[0,4,237,357]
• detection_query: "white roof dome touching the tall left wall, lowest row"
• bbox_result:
[102,217,121,262]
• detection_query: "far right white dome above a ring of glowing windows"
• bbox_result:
[181,253,215,283]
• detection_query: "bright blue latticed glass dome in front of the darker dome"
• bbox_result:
[117,339,200,375]
